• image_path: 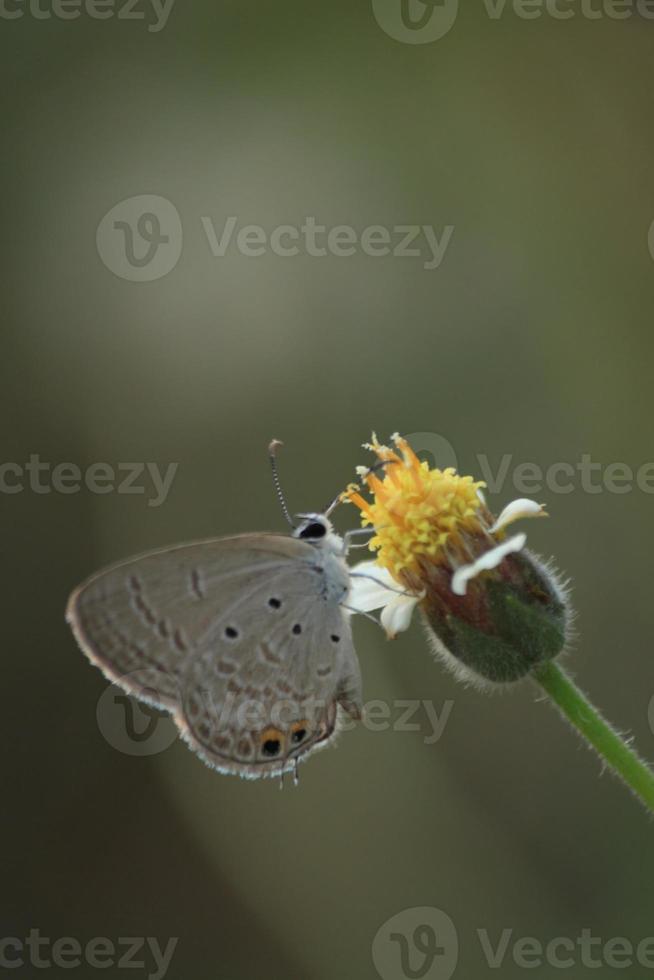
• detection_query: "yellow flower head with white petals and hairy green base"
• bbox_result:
[343,435,565,679]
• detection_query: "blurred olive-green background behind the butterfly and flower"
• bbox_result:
[5,0,654,980]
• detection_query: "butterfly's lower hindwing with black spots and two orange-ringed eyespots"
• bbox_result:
[181,580,361,778]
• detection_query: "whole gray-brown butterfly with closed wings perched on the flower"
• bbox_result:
[66,447,374,778]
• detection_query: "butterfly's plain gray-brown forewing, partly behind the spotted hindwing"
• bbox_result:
[66,534,326,707]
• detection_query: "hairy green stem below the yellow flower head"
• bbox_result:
[534,660,654,812]
